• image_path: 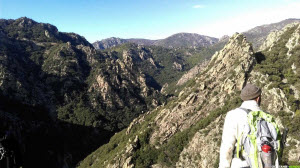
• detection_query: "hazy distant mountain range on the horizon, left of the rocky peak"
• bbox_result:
[93,33,219,50]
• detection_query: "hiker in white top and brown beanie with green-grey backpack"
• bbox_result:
[219,84,280,168]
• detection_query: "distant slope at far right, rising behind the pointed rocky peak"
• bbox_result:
[242,19,300,49]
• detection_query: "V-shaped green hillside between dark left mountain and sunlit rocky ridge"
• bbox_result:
[102,43,221,95]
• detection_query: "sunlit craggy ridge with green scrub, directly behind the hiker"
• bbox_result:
[79,24,300,168]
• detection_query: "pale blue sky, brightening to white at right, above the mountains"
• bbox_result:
[0,0,300,43]
